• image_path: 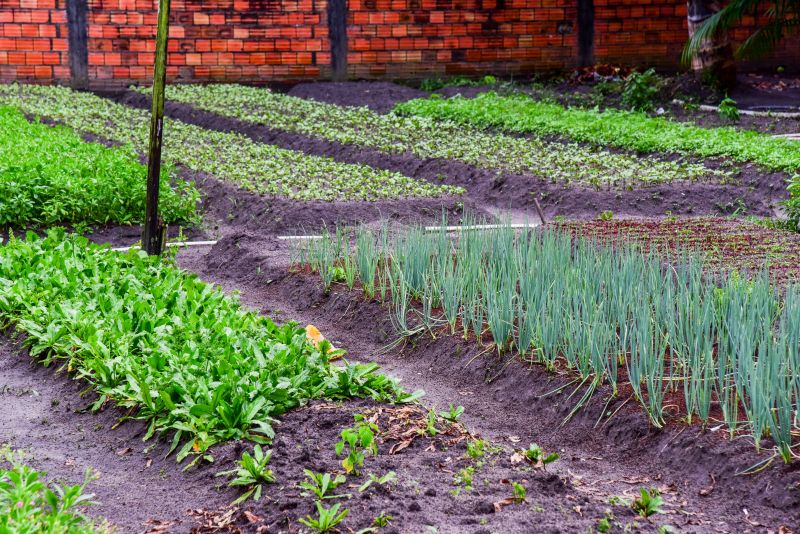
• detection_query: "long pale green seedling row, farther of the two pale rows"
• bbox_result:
[152,85,729,186]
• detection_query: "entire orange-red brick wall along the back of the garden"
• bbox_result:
[0,0,800,86]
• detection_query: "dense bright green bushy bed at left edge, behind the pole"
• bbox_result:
[0,106,199,227]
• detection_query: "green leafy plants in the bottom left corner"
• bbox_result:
[0,446,108,534]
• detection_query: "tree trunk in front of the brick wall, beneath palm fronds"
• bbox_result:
[686,0,736,89]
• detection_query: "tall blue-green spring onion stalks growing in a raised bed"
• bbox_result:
[297,221,800,462]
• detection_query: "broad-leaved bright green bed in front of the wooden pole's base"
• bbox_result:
[0,230,416,461]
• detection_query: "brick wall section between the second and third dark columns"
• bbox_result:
[347,0,577,78]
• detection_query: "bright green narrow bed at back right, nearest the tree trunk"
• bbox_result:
[395,93,800,173]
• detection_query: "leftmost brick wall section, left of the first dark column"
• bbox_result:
[0,0,70,81]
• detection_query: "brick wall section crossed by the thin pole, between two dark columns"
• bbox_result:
[89,0,330,84]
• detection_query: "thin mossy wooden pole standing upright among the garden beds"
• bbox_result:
[142,0,170,256]
